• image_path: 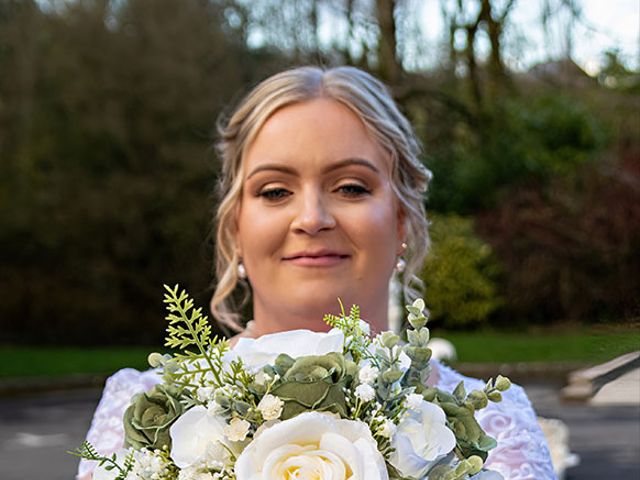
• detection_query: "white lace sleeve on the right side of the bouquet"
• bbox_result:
[438,364,556,480]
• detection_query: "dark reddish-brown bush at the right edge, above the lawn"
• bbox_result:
[476,157,640,324]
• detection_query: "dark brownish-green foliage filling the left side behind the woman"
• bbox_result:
[0,0,281,344]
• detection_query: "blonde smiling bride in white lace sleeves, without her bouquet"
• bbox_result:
[77,67,555,480]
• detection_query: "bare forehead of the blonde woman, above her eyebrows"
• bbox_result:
[243,98,390,174]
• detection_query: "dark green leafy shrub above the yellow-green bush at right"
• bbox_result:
[428,94,607,213]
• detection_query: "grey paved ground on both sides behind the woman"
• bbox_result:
[0,384,640,480]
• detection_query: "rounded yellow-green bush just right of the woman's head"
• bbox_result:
[421,215,502,328]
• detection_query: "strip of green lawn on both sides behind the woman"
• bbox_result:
[0,329,640,378]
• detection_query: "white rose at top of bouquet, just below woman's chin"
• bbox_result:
[229,328,344,372]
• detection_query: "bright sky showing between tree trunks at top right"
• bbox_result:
[421,0,640,75]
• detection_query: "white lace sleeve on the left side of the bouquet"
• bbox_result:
[76,368,160,480]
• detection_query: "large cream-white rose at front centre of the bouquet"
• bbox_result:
[235,412,389,480]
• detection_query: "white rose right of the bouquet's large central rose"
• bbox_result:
[389,400,456,478]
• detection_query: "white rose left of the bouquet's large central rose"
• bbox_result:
[169,405,234,468]
